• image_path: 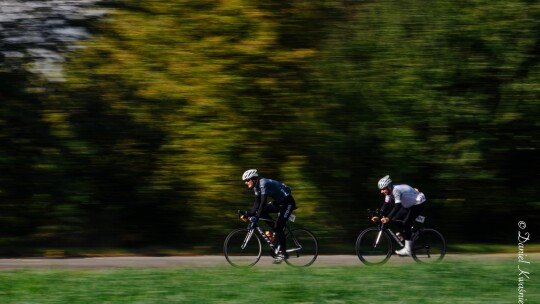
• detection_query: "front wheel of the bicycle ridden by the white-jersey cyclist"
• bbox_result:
[356,227,392,265]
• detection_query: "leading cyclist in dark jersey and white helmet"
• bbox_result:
[242,169,297,263]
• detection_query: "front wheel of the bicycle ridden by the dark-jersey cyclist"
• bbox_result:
[223,228,262,267]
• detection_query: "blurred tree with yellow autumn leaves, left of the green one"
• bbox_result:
[52,1,346,247]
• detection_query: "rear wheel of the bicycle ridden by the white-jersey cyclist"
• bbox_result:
[411,229,446,263]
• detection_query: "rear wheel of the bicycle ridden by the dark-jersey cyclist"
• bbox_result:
[285,229,319,267]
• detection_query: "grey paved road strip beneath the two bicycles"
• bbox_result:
[0,253,540,270]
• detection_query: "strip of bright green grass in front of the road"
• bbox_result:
[0,260,540,304]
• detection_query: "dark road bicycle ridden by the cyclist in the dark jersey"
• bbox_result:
[223,210,319,267]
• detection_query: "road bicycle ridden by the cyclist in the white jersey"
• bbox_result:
[356,210,446,265]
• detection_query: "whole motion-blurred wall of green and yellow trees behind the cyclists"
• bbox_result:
[0,0,540,254]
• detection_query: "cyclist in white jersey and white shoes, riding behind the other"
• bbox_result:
[371,175,426,256]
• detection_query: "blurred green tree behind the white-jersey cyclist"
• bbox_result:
[308,1,539,241]
